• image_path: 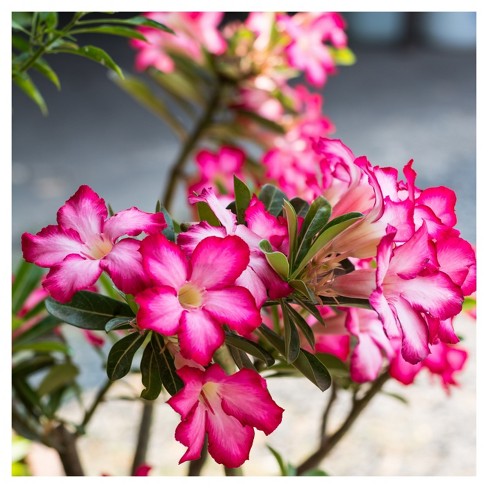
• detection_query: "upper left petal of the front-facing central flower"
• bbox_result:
[140,234,189,290]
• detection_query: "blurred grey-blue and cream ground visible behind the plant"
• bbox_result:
[12,12,476,476]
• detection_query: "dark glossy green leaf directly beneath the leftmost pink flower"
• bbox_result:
[46,291,135,330]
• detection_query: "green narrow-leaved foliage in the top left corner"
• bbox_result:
[12,12,172,115]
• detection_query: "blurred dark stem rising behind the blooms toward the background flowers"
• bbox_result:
[161,78,222,213]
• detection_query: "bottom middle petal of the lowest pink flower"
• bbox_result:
[207,405,254,468]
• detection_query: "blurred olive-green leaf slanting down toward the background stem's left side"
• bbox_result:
[112,72,186,139]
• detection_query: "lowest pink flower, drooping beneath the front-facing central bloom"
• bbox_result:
[168,364,283,468]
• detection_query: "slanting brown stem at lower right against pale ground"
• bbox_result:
[297,371,390,475]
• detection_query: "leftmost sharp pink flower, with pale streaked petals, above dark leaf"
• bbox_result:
[22,185,166,302]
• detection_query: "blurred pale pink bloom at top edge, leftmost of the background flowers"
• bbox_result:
[132,12,226,73]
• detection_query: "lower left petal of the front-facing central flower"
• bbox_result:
[135,286,183,336]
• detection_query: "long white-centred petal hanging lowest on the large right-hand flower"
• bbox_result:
[394,298,430,364]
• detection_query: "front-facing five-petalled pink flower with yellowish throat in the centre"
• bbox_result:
[135,234,261,365]
